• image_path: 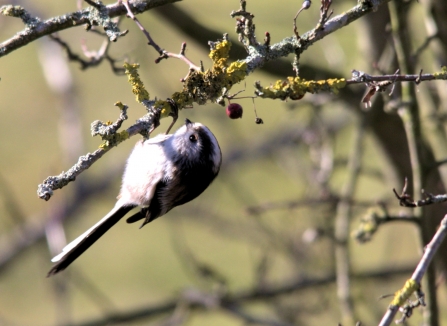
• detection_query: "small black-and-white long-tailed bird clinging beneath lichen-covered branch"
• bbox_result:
[47,119,222,277]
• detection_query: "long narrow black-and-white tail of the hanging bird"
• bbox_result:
[47,202,137,277]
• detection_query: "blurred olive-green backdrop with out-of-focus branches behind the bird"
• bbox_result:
[0,0,447,326]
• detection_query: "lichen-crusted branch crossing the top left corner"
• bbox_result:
[0,0,180,57]
